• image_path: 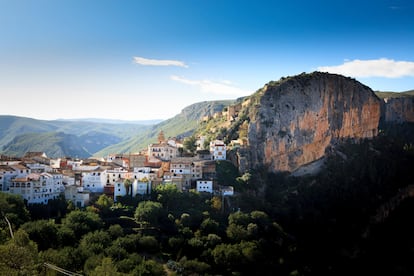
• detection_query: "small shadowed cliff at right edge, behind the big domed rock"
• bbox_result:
[381,97,414,124]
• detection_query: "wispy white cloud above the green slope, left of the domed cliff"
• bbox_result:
[170,76,251,97]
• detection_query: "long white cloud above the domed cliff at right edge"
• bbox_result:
[318,58,414,78]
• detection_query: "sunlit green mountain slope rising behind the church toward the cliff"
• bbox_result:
[94,100,237,157]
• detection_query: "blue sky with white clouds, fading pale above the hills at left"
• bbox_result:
[0,0,414,120]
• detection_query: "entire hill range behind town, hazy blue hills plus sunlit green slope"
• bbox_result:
[0,100,236,158]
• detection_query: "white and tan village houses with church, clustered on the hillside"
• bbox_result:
[0,133,233,207]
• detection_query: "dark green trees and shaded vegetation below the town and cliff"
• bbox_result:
[0,125,414,275]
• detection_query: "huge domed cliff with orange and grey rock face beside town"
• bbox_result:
[248,72,381,171]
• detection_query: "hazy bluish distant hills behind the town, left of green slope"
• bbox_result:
[0,116,151,157]
